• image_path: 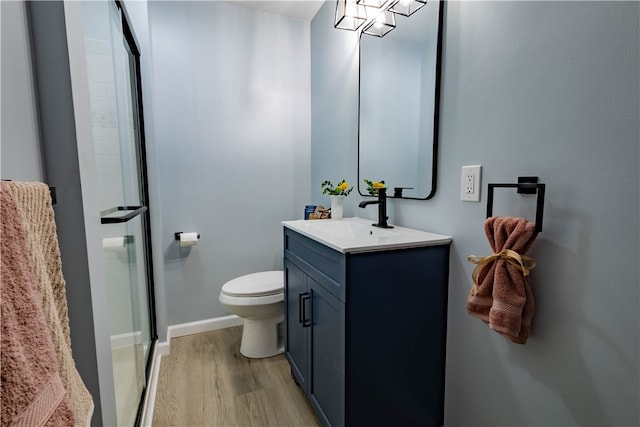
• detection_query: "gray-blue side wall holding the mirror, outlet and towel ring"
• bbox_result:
[311,2,640,426]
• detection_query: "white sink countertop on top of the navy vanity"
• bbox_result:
[282,217,451,253]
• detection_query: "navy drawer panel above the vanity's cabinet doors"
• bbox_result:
[284,228,346,302]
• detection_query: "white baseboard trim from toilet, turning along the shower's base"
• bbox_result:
[140,315,244,427]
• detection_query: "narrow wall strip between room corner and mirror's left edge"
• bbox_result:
[311,2,360,218]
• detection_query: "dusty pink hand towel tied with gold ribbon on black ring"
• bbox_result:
[467,217,537,344]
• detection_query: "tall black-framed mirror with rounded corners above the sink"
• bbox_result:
[358,1,444,200]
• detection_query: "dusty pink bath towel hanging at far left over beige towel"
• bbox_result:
[0,187,75,427]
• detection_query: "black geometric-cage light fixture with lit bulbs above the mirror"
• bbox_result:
[333,0,427,37]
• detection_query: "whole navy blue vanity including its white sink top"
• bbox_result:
[283,218,451,427]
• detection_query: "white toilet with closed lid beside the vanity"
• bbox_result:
[218,271,284,359]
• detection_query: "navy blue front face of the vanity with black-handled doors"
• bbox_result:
[284,233,345,426]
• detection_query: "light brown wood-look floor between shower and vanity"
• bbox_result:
[153,326,320,427]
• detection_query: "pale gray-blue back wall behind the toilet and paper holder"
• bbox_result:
[148,2,310,332]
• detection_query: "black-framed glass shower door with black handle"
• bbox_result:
[83,1,156,426]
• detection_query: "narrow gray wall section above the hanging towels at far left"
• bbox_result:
[0,1,44,181]
